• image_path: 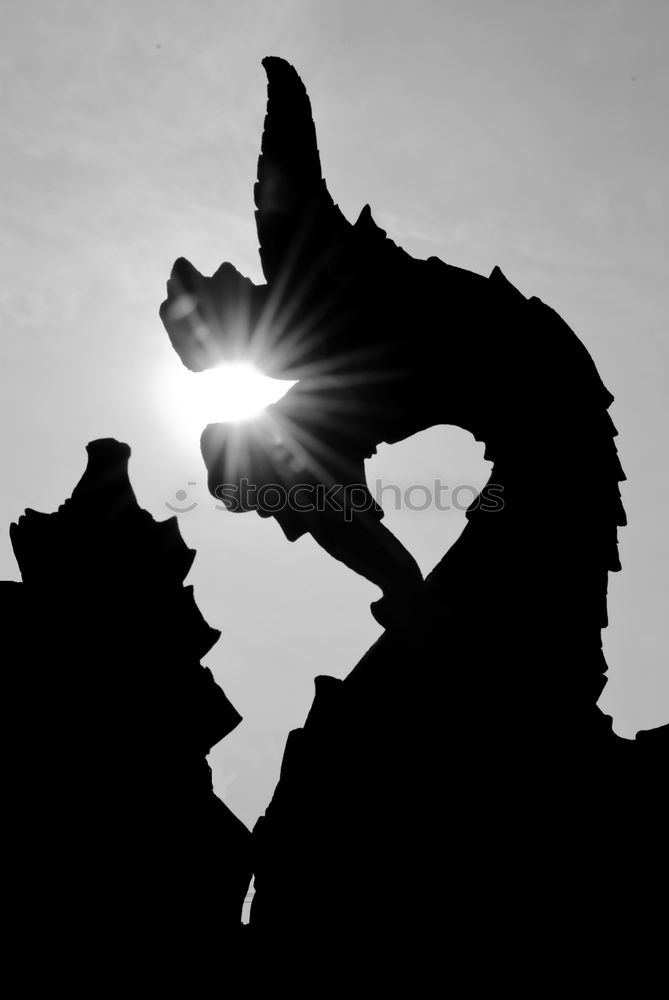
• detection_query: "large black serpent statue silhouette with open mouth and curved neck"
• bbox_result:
[161,58,667,976]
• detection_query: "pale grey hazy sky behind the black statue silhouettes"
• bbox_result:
[0,0,669,823]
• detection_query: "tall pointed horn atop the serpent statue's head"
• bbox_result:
[254,56,351,283]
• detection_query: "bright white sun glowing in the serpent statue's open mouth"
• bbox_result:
[160,361,295,438]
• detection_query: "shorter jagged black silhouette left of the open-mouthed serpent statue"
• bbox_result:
[0,439,251,984]
